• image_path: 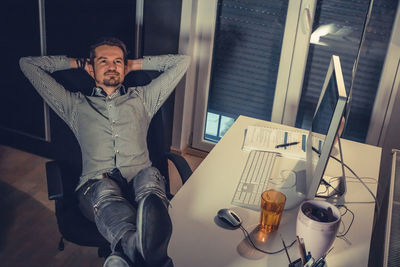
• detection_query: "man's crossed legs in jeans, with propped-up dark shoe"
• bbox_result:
[78,167,173,267]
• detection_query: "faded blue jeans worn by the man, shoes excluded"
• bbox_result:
[78,167,168,254]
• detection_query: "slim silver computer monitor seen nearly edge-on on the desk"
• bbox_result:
[306,55,347,199]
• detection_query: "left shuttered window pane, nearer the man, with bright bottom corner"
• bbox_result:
[205,0,288,141]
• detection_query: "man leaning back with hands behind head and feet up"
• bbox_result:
[20,38,189,266]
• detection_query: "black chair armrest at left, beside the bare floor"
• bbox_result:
[46,161,64,200]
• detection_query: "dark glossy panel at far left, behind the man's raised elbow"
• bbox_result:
[0,0,44,138]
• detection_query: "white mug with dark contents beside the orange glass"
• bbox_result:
[296,200,341,260]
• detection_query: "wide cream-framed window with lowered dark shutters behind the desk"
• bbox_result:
[184,0,398,150]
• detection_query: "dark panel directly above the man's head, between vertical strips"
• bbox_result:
[46,0,136,57]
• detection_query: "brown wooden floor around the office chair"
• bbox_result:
[0,146,202,267]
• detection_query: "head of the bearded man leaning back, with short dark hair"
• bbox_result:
[89,37,127,94]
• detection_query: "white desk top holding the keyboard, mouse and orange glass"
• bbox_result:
[168,116,381,267]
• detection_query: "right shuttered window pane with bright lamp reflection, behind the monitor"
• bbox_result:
[296,0,398,142]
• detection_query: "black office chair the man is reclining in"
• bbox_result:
[46,72,192,257]
